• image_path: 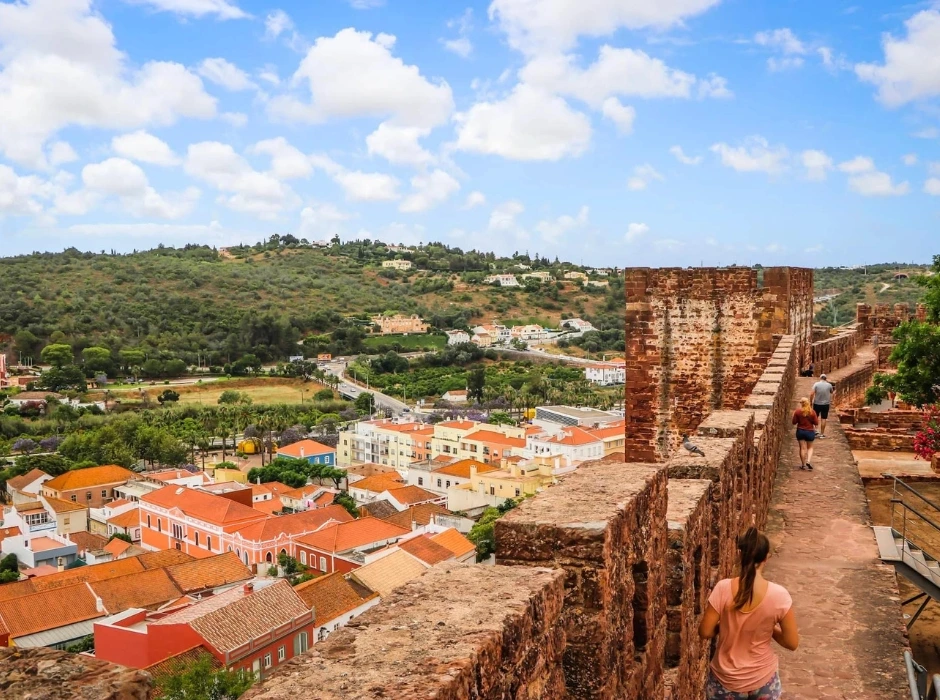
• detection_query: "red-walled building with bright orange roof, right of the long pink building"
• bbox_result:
[296,518,411,573]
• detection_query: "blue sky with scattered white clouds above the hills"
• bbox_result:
[0,0,940,266]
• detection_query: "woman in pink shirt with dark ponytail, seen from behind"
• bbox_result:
[699,527,800,700]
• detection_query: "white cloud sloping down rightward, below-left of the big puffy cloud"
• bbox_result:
[184,141,298,218]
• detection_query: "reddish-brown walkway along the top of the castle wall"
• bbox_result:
[767,379,906,700]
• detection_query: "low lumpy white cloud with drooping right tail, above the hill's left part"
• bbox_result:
[80,158,200,219]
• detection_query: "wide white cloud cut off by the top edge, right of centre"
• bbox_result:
[489,0,719,52]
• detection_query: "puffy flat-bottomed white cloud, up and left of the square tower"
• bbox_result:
[455,84,591,160]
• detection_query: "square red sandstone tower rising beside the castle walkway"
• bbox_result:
[625,268,813,462]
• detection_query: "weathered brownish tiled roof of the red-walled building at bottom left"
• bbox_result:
[152,579,310,653]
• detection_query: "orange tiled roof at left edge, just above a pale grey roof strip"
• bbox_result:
[0,574,107,638]
